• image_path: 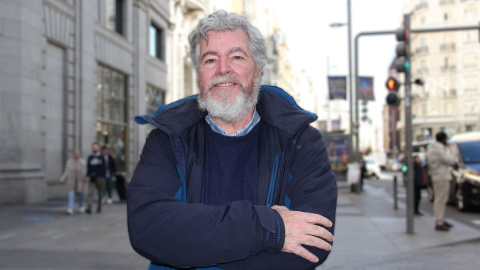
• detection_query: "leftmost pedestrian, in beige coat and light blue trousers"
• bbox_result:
[60,150,85,215]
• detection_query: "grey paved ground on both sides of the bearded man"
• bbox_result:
[0,183,480,270]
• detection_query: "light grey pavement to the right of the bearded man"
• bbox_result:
[317,183,480,270]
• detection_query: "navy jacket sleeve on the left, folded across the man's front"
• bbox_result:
[127,130,283,268]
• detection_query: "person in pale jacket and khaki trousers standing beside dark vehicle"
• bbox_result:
[427,132,455,231]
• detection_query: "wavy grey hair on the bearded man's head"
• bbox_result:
[188,10,267,73]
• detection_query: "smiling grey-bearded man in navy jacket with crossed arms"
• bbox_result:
[127,11,337,269]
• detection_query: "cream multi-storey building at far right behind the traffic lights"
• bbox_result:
[398,0,480,148]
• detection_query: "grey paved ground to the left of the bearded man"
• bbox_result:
[0,200,148,270]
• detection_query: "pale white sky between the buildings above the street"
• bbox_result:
[275,0,404,124]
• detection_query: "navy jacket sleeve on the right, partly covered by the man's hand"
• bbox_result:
[220,128,337,270]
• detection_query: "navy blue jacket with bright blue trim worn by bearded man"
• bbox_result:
[127,86,337,270]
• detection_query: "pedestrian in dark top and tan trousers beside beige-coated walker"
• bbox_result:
[85,142,106,214]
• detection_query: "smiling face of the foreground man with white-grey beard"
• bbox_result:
[198,29,261,122]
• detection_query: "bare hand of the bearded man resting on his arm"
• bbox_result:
[272,205,333,263]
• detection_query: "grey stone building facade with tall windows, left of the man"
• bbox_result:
[0,0,208,204]
